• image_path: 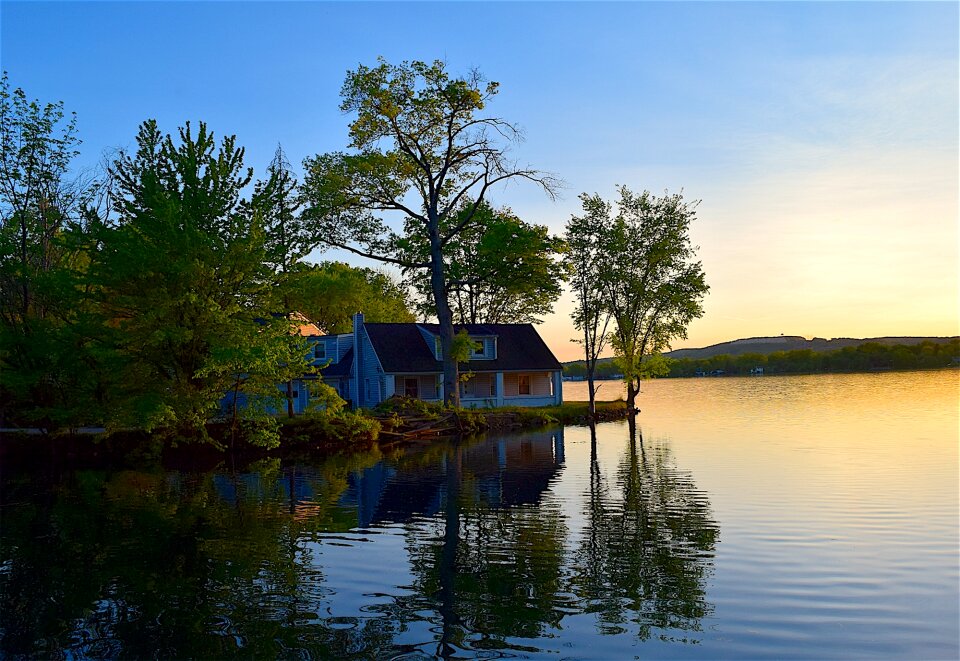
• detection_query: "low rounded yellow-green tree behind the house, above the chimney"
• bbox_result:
[283,262,415,333]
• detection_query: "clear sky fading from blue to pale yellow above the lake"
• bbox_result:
[0,0,960,360]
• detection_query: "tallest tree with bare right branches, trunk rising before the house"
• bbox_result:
[304,58,555,405]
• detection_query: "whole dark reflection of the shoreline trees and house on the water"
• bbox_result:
[0,429,717,658]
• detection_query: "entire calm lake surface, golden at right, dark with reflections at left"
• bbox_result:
[0,371,960,659]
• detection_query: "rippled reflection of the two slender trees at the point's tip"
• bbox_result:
[573,424,719,640]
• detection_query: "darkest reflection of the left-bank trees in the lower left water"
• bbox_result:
[0,446,394,658]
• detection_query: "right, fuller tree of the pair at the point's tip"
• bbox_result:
[590,186,709,411]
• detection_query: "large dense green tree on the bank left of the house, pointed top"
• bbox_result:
[91,120,307,432]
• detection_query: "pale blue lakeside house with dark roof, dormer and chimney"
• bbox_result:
[308,313,563,411]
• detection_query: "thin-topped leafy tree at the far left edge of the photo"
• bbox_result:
[0,73,98,427]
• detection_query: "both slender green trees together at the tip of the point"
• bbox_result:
[567,187,709,408]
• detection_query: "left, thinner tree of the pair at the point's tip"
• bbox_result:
[565,194,610,419]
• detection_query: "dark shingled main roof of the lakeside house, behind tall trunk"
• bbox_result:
[364,323,562,374]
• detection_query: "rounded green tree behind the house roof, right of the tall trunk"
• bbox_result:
[411,202,567,324]
